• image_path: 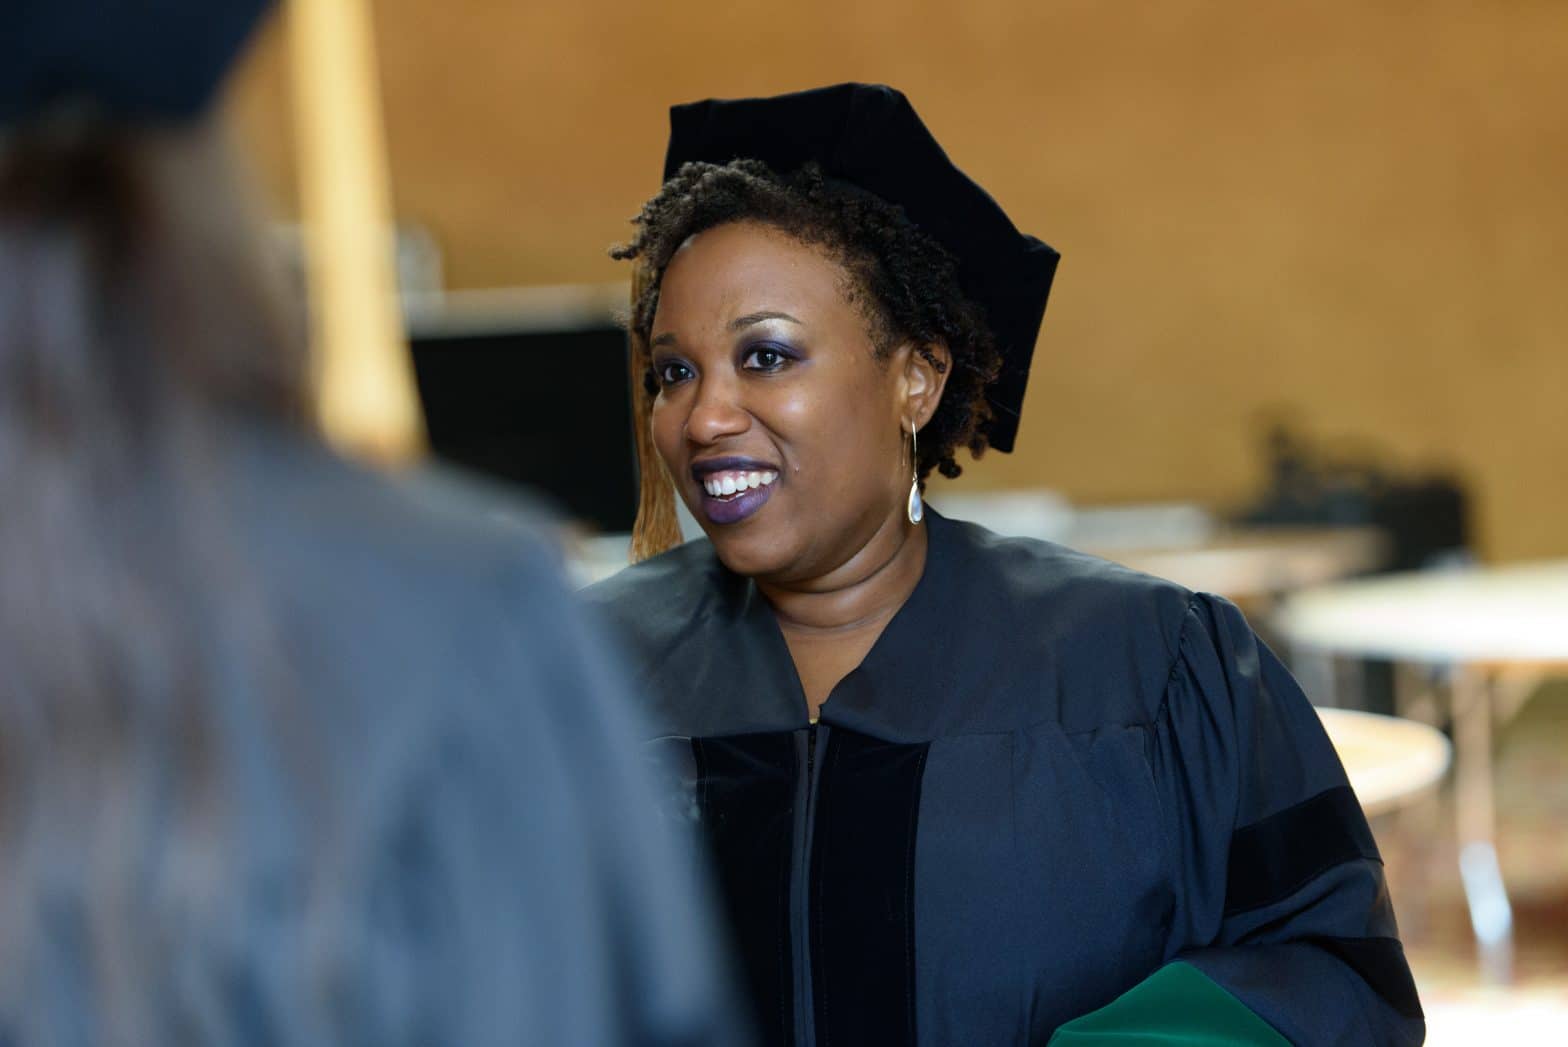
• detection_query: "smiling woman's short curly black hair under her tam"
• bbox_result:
[610,160,1002,480]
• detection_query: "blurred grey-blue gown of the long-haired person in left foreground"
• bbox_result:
[0,416,742,1047]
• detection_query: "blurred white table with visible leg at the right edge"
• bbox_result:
[1275,561,1568,981]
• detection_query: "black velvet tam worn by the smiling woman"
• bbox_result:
[665,83,1060,451]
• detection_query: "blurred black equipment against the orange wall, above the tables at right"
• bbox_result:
[1234,425,1471,571]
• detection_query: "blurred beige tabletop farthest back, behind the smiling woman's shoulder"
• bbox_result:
[1082,527,1388,603]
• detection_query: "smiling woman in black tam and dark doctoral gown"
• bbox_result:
[590,85,1424,1044]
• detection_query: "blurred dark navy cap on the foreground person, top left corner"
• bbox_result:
[0,0,271,129]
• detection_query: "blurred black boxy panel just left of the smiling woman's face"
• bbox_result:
[409,297,637,533]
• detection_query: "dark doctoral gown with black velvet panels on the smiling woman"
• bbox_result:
[588,513,1424,1047]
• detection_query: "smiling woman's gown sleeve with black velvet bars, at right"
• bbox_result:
[1058,596,1425,1044]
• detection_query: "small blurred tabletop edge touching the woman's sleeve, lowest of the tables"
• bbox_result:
[1317,708,1452,818]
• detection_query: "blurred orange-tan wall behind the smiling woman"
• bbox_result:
[232,0,1568,560]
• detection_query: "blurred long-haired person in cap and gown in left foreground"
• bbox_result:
[0,0,735,1047]
